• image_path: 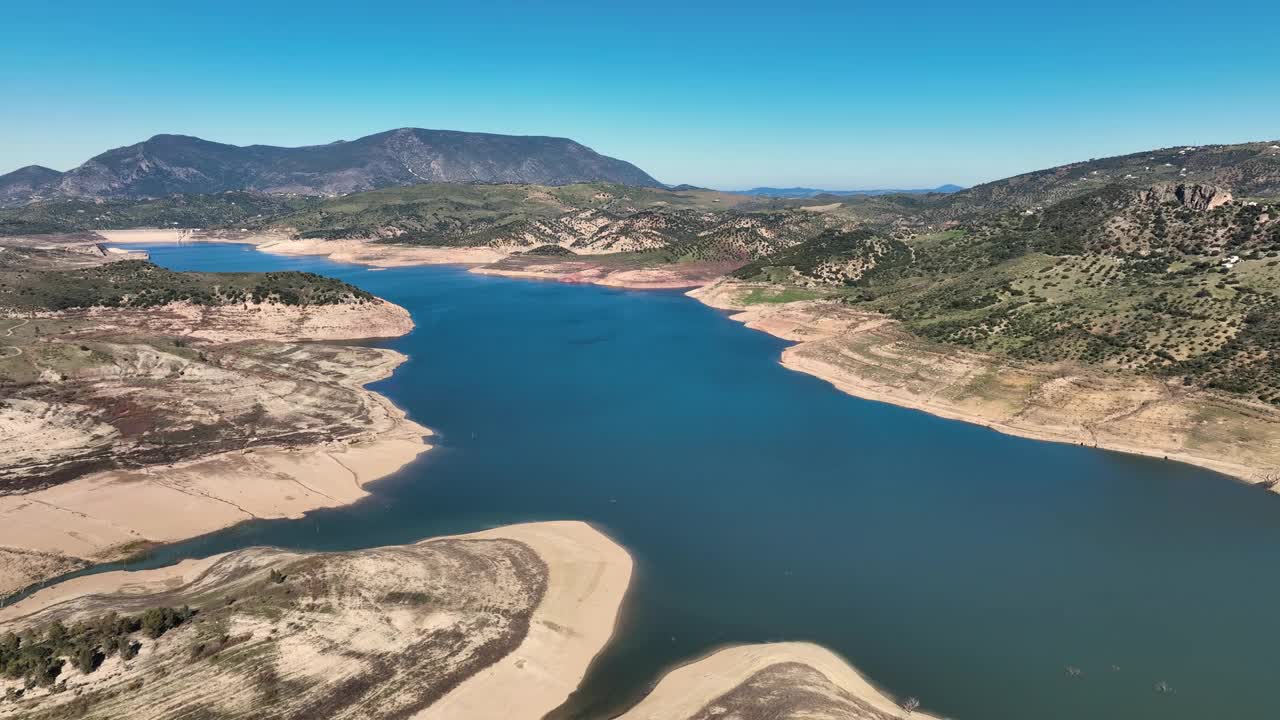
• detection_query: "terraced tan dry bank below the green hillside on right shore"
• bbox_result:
[689,281,1280,482]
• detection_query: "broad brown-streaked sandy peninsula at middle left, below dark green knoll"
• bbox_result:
[0,245,431,597]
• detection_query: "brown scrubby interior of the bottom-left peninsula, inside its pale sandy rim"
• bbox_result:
[0,538,548,720]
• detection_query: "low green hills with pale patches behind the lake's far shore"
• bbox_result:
[268,183,847,263]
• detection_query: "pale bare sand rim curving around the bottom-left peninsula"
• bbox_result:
[0,520,634,720]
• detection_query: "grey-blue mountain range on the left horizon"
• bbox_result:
[0,128,663,206]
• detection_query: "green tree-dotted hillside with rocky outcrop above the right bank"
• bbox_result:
[737,179,1280,404]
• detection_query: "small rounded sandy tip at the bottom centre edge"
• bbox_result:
[620,643,933,720]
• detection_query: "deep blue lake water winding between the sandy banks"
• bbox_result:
[80,245,1280,720]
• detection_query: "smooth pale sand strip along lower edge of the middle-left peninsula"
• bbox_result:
[0,350,431,596]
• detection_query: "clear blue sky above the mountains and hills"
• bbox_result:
[0,0,1280,188]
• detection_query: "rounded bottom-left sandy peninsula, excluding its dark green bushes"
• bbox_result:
[0,521,631,720]
